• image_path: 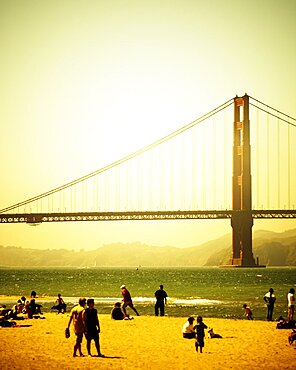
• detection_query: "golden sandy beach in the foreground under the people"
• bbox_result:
[0,313,296,369]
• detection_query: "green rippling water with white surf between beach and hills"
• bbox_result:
[0,267,296,320]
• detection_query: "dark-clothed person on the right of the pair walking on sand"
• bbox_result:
[82,298,104,357]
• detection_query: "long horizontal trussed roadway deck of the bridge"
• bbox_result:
[0,209,296,225]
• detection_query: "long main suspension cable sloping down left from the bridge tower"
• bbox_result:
[0,99,233,213]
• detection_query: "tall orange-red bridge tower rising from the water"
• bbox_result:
[230,95,255,267]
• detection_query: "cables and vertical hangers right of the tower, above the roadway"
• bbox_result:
[250,97,296,209]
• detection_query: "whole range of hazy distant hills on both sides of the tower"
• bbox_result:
[0,229,296,267]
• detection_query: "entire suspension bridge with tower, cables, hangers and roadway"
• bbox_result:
[0,95,296,266]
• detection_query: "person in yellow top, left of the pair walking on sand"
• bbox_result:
[67,298,86,357]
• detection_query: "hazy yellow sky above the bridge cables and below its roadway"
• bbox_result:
[0,0,296,249]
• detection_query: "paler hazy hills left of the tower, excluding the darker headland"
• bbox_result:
[0,236,229,267]
